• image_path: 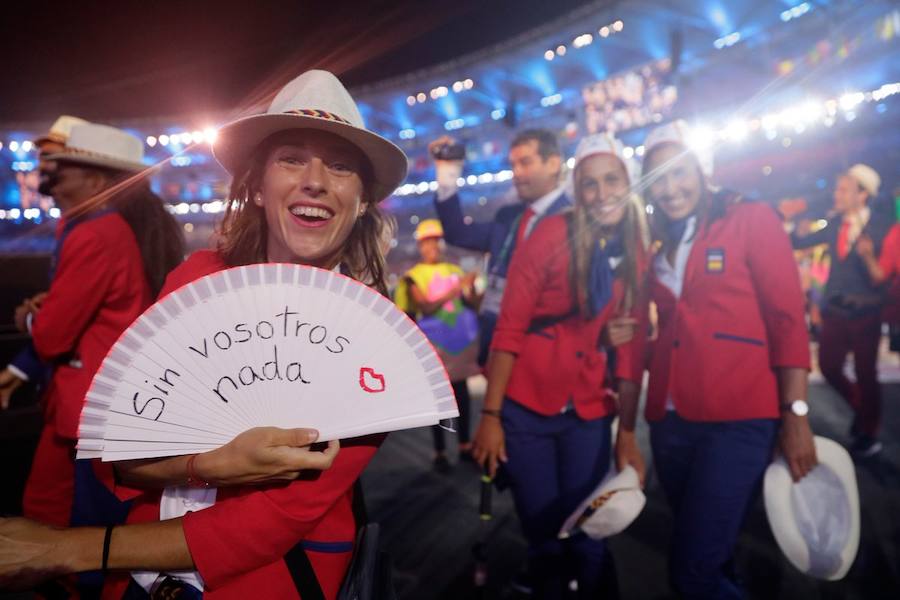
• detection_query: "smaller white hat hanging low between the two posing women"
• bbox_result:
[559,465,647,540]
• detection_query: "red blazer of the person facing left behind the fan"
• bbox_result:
[31,212,153,440]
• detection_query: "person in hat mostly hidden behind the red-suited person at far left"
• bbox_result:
[0,115,87,409]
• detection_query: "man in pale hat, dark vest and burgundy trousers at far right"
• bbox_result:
[791,164,895,458]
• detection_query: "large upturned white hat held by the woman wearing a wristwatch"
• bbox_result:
[763,436,860,580]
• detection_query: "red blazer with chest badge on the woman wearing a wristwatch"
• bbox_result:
[646,203,809,421]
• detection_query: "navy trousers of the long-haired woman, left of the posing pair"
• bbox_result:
[502,398,612,600]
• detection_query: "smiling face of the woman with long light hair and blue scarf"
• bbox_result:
[575,153,629,225]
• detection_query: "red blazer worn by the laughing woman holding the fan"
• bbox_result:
[103,251,384,600]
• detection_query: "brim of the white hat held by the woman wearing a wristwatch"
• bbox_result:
[763,436,860,581]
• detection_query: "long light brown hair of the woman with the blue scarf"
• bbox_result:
[566,187,649,317]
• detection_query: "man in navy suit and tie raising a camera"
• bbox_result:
[428,129,571,365]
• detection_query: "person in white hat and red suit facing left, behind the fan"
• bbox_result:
[23,124,152,525]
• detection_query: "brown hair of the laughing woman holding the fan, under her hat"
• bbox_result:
[218,134,393,295]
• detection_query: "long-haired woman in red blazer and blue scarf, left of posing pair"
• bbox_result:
[474,134,647,599]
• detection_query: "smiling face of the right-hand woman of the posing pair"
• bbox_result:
[644,143,704,221]
